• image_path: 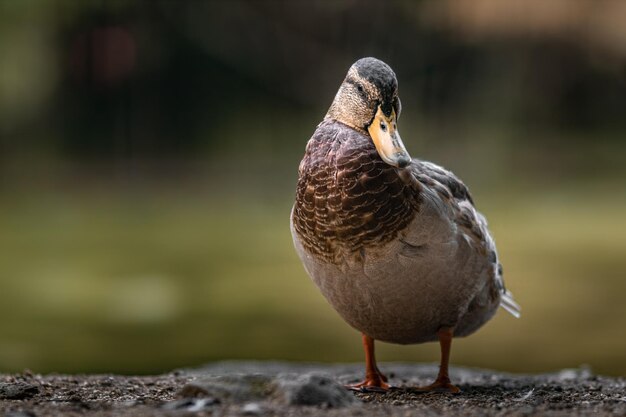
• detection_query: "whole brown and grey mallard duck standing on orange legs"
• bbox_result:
[291,58,520,392]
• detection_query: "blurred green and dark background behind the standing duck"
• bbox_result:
[0,0,626,375]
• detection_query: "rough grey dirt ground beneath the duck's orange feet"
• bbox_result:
[0,362,626,417]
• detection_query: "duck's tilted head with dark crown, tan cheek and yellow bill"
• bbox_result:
[326,58,411,168]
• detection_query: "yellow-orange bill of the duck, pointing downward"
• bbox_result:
[367,106,411,168]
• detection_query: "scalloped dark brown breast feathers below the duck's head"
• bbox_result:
[293,120,419,262]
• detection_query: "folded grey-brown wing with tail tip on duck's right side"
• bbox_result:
[411,159,521,317]
